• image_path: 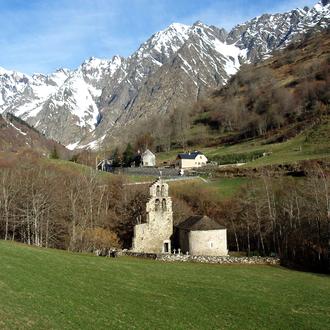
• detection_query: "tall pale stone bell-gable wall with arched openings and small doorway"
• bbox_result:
[132,178,173,253]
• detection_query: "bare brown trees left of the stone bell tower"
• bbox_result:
[0,159,148,251]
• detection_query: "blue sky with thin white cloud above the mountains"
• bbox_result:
[0,0,317,74]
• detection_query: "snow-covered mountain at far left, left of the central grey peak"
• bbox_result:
[0,56,123,144]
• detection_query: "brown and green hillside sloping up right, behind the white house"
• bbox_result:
[140,31,330,168]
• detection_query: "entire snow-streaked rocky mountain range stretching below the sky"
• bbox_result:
[0,0,330,148]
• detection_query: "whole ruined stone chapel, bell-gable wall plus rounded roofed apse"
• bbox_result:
[132,178,228,256]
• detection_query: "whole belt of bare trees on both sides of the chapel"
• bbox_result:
[0,157,330,272]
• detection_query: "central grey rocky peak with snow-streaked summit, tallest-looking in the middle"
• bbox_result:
[93,22,245,143]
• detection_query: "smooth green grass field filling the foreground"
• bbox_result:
[0,241,330,329]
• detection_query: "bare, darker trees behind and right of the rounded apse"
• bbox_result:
[174,166,330,273]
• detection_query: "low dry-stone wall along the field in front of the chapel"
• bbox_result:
[119,251,280,265]
